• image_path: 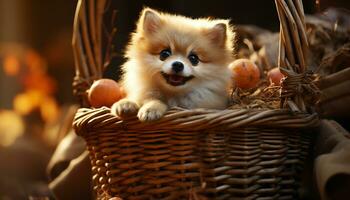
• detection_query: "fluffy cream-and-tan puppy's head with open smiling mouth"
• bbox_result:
[126,8,234,92]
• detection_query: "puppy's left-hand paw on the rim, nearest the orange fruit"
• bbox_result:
[111,99,139,118]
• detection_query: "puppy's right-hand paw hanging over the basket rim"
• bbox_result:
[137,100,168,122]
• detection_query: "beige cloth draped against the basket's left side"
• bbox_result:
[47,130,92,200]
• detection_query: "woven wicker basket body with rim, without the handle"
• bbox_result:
[74,108,317,199]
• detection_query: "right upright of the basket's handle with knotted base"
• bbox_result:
[275,0,320,112]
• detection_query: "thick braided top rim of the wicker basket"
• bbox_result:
[73,107,318,137]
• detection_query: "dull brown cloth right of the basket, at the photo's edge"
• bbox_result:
[314,120,350,200]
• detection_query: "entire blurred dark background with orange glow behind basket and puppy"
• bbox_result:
[0,0,350,200]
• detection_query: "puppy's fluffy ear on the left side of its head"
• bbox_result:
[142,8,163,34]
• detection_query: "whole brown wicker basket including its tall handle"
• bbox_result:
[73,0,318,200]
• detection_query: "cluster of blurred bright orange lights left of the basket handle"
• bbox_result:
[3,45,60,123]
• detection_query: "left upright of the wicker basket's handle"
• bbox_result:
[72,0,116,107]
